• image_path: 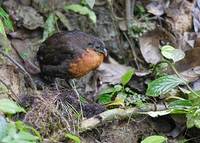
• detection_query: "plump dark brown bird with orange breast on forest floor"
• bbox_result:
[37,30,108,79]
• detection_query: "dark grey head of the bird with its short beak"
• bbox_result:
[88,38,108,57]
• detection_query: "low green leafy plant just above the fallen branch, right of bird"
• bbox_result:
[98,69,146,107]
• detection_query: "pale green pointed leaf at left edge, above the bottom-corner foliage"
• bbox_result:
[0,99,25,114]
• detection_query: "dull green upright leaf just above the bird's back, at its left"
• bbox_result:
[42,12,58,41]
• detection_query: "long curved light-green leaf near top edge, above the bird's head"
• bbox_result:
[64,4,97,24]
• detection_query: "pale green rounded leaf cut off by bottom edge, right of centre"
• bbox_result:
[141,135,167,143]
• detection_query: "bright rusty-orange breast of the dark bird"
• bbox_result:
[69,49,104,78]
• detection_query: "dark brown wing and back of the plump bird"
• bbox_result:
[38,32,86,65]
